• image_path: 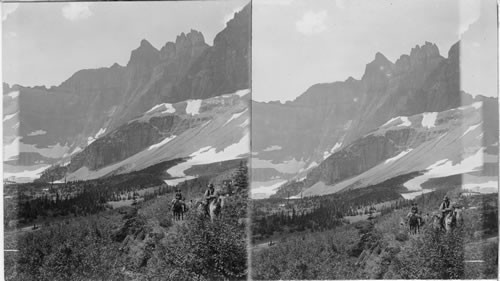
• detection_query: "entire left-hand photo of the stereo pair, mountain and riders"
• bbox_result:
[2,0,251,280]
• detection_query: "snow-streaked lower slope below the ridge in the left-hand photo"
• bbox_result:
[67,90,250,180]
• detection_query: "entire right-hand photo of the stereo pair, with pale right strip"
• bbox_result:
[249,0,499,280]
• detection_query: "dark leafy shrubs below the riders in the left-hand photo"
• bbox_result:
[5,161,248,280]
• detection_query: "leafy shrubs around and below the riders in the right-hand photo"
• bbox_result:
[252,189,498,280]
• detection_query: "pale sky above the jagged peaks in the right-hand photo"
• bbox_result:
[252,0,498,102]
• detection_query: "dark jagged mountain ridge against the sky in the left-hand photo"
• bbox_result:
[3,5,251,184]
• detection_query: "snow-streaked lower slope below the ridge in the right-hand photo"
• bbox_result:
[279,97,498,198]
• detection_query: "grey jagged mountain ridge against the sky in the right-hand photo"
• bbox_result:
[252,42,494,198]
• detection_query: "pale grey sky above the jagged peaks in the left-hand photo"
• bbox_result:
[2,0,249,87]
